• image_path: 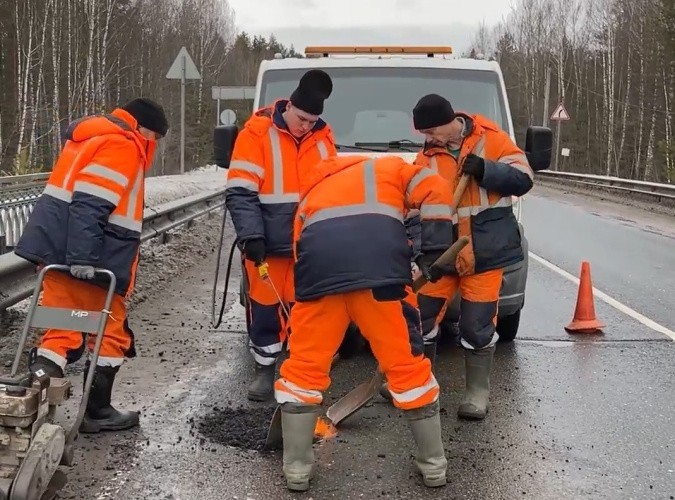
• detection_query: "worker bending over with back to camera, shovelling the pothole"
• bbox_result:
[275,156,452,491]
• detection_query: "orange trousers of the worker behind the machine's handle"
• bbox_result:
[37,271,136,369]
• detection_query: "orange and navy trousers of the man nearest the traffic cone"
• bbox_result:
[417,269,503,349]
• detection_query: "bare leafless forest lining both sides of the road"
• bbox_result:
[0,0,675,182]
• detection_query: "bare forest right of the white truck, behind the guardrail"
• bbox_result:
[467,0,675,182]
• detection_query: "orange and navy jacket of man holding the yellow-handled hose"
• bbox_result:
[226,100,337,257]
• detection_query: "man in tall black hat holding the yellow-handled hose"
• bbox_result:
[226,70,337,401]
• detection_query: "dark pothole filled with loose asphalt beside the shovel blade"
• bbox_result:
[190,406,276,451]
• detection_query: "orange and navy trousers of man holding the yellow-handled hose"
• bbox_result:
[244,257,295,366]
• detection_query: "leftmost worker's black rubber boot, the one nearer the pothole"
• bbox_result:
[80,361,139,434]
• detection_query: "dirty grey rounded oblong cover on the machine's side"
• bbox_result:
[9,423,66,500]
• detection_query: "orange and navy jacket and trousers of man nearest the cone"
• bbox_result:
[415,113,533,349]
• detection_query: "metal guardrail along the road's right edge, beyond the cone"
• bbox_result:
[536,170,675,204]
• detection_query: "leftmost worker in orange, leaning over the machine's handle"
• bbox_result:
[14,98,168,433]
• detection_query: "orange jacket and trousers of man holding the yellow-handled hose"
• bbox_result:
[226,100,337,366]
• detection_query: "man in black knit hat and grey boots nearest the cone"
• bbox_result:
[380,94,534,420]
